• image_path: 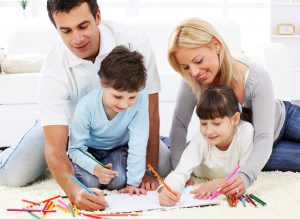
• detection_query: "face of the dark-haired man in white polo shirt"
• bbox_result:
[53,3,100,61]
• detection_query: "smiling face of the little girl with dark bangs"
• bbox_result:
[200,113,240,151]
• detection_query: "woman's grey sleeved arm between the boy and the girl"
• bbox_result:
[170,81,196,169]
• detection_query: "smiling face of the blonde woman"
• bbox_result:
[175,44,220,85]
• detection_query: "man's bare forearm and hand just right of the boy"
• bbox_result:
[140,93,159,190]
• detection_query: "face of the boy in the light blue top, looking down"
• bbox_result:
[102,87,138,113]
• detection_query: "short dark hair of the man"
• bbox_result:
[47,0,99,26]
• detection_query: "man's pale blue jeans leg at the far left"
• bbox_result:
[0,122,47,187]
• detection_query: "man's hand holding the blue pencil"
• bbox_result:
[73,188,107,211]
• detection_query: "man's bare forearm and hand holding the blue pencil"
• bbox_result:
[44,125,106,211]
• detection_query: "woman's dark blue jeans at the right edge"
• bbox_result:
[263,102,300,171]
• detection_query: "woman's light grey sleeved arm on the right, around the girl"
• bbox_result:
[238,66,275,188]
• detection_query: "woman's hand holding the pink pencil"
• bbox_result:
[221,175,245,198]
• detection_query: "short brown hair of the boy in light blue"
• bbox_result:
[98,46,147,92]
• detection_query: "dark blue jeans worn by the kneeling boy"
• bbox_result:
[73,145,128,190]
